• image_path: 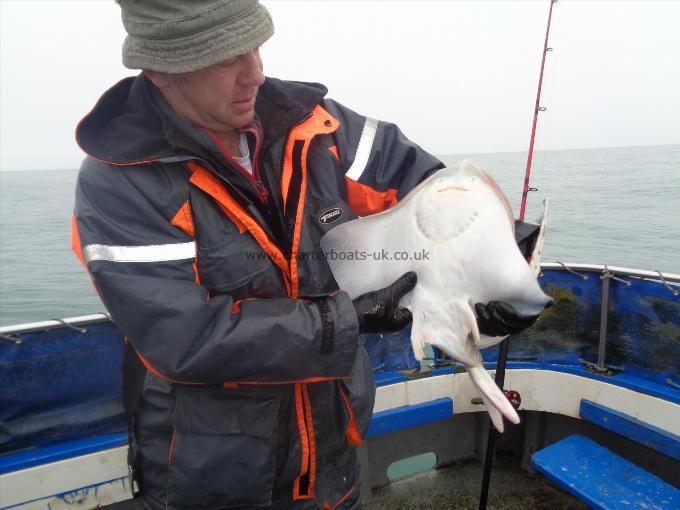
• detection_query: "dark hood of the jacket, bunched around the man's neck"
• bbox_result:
[76,73,327,165]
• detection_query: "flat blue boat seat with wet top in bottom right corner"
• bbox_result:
[531,435,680,510]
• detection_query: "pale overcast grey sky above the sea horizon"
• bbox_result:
[0,0,680,170]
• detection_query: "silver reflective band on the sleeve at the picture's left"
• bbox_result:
[83,241,196,262]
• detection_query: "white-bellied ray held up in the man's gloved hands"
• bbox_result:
[321,160,551,432]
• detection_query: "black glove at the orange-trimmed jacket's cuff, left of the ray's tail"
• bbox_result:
[352,271,418,333]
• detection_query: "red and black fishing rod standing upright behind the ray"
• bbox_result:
[479,0,557,510]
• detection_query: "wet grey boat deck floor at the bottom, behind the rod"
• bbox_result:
[364,456,587,510]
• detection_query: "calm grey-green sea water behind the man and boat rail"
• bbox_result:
[0,145,680,326]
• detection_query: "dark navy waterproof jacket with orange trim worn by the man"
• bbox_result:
[72,74,442,508]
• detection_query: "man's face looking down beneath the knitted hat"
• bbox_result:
[150,49,264,131]
